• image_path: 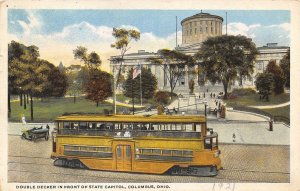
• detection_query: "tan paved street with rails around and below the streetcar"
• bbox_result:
[8,135,290,183]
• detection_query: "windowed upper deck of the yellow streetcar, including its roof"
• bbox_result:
[56,114,206,138]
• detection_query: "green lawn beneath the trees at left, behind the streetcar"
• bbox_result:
[9,97,124,122]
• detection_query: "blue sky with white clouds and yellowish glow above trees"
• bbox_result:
[8,9,290,70]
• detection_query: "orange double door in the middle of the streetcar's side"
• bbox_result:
[116,145,132,171]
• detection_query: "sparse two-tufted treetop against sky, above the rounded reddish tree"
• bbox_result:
[73,46,101,69]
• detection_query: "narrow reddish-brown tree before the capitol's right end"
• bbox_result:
[266,60,285,95]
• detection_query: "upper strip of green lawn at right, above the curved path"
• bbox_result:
[224,93,290,107]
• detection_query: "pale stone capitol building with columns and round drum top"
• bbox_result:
[110,12,289,93]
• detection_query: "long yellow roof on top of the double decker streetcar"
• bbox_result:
[56,114,206,123]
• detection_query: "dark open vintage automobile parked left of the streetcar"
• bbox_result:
[21,125,49,141]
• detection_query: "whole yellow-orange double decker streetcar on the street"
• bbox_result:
[51,114,221,176]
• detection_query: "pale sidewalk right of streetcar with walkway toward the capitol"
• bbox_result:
[168,94,290,145]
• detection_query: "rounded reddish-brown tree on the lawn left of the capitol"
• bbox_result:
[85,69,112,107]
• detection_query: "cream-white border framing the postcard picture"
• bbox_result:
[0,0,300,191]
